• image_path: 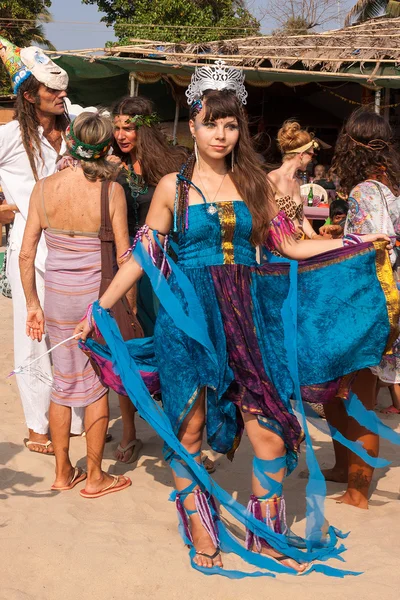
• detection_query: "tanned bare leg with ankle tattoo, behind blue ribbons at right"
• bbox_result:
[336,369,379,509]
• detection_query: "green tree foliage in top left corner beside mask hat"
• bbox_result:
[0,0,54,95]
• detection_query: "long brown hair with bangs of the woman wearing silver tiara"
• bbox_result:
[178,90,278,246]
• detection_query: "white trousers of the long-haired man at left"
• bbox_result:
[7,245,84,435]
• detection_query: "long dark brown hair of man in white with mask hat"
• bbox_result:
[13,75,69,181]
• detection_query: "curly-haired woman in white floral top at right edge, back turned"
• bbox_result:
[324,109,400,509]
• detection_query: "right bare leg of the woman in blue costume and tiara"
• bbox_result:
[242,413,307,572]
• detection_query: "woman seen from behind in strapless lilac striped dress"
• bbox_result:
[19,112,131,498]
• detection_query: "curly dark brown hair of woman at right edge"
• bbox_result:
[330,108,400,195]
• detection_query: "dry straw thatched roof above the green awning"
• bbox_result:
[106,18,400,77]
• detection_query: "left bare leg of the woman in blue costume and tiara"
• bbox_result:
[173,390,222,567]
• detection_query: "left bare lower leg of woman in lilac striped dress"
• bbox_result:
[49,402,74,487]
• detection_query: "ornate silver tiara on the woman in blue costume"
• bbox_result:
[185,60,248,104]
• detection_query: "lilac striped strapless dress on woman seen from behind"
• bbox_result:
[44,231,107,407]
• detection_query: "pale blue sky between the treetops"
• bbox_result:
[45,0,355,50]
